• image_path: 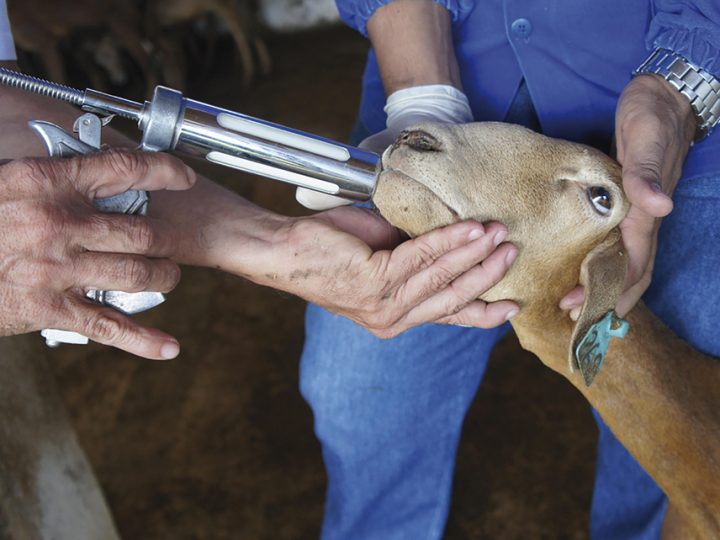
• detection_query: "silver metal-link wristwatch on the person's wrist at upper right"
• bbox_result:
[633,49,720,142]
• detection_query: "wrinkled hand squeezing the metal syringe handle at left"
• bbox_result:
[0,151,195,359]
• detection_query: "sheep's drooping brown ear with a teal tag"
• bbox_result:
[569,229,627,386]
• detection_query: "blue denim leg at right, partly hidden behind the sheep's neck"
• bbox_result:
[591,176,720,540]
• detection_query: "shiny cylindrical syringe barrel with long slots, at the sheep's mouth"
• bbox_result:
[139,86,379,201]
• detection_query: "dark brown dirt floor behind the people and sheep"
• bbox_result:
[52,28,596,540]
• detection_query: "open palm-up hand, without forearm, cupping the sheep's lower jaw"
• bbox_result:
[256,207,519,338]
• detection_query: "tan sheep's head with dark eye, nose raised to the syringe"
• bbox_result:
[373,123,628,384]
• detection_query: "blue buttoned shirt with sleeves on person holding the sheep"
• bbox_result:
[337,0,720,180]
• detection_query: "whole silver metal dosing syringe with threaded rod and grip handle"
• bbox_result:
[0,68,379,346]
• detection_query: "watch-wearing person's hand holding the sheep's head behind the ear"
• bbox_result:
[560,71,696,318]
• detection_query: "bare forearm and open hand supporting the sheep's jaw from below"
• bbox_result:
[153,167,519,338]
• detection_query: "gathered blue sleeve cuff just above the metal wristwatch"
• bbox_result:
[647,0,720,76]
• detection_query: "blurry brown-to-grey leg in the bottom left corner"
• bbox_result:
[0,336,119,540]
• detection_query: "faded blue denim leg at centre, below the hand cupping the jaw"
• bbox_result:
[300,305,508,540]
